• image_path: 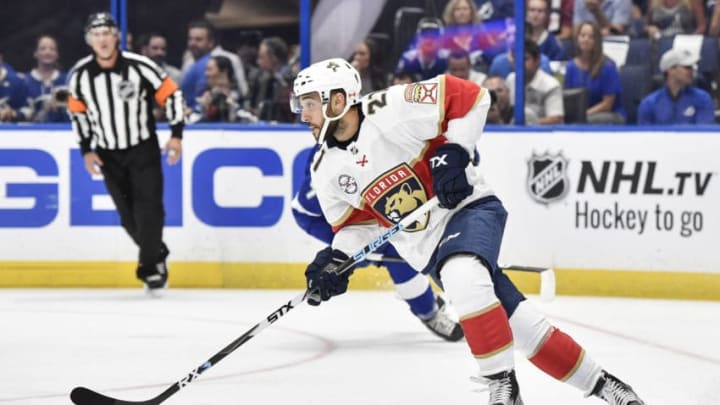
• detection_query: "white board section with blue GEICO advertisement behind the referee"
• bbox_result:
[0,130,320,262]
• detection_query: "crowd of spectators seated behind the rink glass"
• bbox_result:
[0,0,720,124]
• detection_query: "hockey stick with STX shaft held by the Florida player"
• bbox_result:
[70,197,438,405]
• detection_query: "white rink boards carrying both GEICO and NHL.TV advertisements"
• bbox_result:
[0,130,720,272]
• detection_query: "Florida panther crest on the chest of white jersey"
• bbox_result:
[362,163,430,232]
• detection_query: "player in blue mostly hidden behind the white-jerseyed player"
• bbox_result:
[292,143,463,342]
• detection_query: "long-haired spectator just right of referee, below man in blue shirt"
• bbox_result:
[198,56,239,122]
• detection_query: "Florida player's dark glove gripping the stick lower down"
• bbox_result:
[305,247,352,305]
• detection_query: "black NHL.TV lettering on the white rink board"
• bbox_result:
[577,160,714,196]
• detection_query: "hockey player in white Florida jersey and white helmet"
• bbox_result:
[291,59,643,405]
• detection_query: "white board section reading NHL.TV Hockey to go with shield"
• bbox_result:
[480,132,720,272]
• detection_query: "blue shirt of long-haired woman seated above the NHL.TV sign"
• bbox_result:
[563,58,627,118]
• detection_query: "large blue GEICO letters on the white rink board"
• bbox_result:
[0,148,311,228]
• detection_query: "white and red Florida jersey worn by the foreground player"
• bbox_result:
[311,75,493,270]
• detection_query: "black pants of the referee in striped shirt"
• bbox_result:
[96,137,165,264]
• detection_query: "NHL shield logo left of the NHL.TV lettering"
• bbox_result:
[527,152,570,204]
